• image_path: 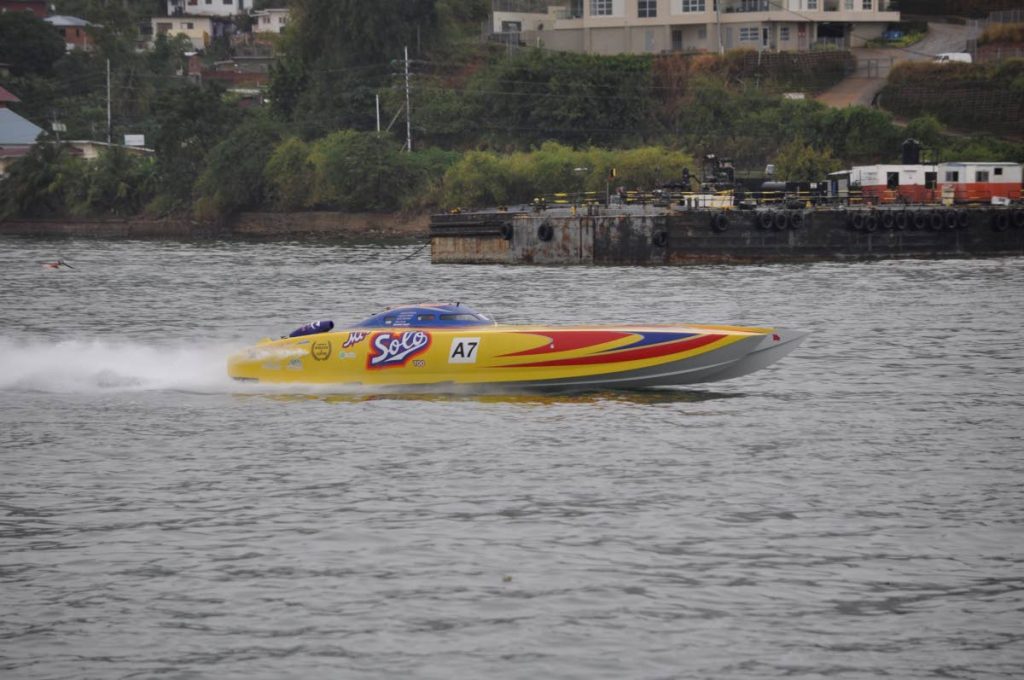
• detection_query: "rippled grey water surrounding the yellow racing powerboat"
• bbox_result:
[0,239,1024,679]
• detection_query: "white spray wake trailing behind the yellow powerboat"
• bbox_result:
[0,337,234,392]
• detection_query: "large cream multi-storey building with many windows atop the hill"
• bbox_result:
[499,0,900,54]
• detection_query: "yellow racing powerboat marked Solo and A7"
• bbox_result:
[227,303,807,389]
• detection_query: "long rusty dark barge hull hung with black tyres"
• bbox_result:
[430,206,1024,265]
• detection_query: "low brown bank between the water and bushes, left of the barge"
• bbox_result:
[0,211,430,241]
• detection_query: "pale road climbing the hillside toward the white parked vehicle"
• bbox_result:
[815,23,980,108]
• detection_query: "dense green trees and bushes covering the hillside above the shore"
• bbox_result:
[0,0,1024,220]
